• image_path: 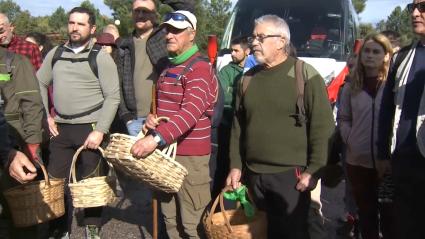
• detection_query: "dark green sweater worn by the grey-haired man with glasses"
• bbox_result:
[230,57,334,174]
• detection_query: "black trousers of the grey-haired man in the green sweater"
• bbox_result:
[246,169,311,239]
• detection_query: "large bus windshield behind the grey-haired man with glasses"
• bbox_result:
[231,0,344,59]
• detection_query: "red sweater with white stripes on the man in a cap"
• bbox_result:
[156,53,217,156]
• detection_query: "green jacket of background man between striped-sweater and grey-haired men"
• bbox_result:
[218,62,243,126]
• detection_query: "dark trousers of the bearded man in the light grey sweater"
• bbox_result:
[47,124,105,230]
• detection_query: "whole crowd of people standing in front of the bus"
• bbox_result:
[0,0,425,239]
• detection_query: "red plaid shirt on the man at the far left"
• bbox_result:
[7,35,43,71]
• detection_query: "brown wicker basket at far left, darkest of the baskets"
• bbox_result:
[3,161,65,227]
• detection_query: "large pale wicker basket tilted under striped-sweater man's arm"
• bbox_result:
[105,117,188,193]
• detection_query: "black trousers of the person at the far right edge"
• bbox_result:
[392,150,425,239]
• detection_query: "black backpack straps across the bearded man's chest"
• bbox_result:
[52,44,102,78]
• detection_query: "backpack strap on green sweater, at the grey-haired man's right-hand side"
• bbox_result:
[293,59,307,126]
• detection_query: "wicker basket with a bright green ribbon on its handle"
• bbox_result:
[203,187,267,239]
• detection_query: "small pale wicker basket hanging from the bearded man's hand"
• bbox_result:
[68,146,116,208]
